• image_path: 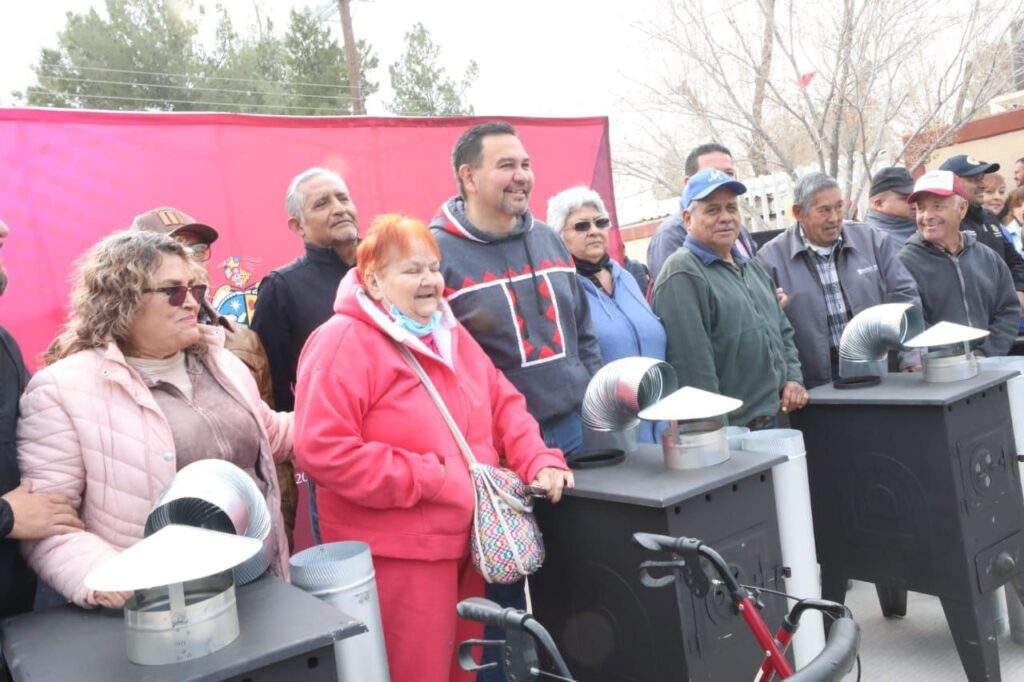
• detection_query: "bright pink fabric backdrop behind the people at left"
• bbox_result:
[0,109,623,546]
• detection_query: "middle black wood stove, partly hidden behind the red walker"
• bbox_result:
[529,444,785,682]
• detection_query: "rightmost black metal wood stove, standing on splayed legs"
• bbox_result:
[792,372,1024,682]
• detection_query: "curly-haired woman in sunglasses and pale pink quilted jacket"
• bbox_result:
[17,231,293,608]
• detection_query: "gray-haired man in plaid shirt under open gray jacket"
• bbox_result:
[757,173,921,388]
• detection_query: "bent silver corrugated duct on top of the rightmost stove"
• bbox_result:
[839,303,925,378]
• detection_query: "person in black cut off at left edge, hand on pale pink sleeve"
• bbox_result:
[0,221,82,619]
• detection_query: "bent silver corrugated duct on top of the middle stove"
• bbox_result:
[583,356,679,431]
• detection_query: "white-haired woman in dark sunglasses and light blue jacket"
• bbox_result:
[548,185,666,442]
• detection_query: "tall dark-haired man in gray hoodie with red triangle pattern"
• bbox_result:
[430,122,601,682]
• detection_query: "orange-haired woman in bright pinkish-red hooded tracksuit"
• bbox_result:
[295,215,572,682]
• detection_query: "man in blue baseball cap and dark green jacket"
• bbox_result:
[651,169,807,429]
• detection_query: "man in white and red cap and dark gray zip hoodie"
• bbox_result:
[899,170,1020,356]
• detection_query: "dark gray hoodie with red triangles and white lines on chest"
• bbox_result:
[430,197,601,423]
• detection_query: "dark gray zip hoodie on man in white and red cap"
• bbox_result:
[899,230,1020,357]
